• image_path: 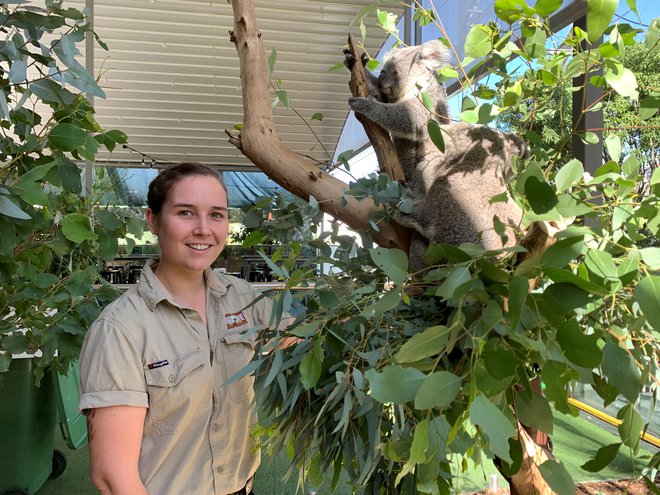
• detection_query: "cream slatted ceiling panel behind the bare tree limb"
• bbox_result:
[71,0,402,169]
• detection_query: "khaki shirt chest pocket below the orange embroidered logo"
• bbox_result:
[220,332,257,402]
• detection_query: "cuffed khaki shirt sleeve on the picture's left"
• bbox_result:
[79,319,149,411]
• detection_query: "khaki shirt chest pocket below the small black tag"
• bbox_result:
[144,349,211,435]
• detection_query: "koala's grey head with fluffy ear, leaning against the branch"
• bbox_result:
[378,40,449,103]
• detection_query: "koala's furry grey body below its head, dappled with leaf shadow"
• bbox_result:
[397,123,527,269]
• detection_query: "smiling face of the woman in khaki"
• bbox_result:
[147,175,229,278]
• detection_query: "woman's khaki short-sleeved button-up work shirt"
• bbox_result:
[80,261,272,495]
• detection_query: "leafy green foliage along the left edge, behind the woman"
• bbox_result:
[0,0,135,379]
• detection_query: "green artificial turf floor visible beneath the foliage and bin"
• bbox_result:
[37,415,650,495]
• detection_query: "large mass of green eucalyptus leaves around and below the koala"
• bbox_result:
[237,0,660,494]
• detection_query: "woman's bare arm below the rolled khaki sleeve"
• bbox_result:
[87,406,147,495]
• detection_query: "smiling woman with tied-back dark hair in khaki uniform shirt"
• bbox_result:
[80,163,271,495]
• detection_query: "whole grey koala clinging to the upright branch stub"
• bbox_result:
[345,41,527,269]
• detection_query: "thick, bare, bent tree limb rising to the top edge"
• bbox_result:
[226,0,410,252]
